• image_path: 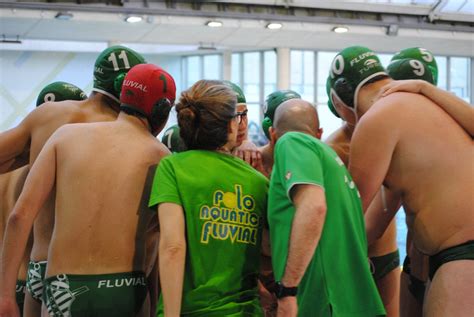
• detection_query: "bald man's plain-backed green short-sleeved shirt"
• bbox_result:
[268,132,385,317]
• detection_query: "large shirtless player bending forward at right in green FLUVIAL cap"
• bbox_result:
[331,47,474,316]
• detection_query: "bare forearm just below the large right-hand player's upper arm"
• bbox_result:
[365,186,401,246]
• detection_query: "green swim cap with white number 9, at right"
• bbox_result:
[387,58,435,85]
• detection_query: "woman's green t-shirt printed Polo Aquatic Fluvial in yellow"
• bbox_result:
[149,150,268,316]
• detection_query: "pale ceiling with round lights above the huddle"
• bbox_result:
[0,0,474,56]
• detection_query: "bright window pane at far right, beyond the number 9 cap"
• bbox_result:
[449,57,470,102]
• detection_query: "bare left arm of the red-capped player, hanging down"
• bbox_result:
[0,138,56,298]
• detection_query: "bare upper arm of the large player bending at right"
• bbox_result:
[349,110,398,213]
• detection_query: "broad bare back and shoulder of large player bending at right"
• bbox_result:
[351,93,474,255]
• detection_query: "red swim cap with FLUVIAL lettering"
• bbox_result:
[120,64,176,130]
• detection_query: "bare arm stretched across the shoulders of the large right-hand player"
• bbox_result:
[382,80,474,137]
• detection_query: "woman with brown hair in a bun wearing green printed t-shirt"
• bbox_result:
[149,80,268,316]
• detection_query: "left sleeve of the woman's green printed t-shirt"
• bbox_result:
[148,156,182,209]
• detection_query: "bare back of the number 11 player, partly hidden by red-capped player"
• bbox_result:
[28,99,117,261]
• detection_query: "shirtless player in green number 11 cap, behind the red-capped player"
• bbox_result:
[0,46,145,316]
